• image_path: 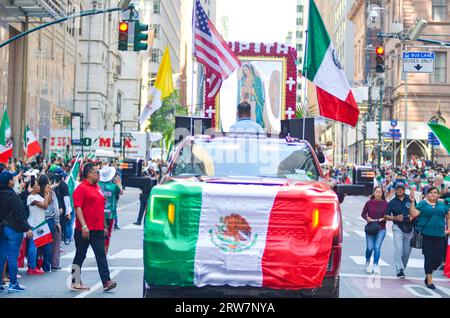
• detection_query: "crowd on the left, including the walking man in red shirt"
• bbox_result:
[0,155,137,293]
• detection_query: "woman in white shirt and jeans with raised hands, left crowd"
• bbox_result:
[27,176,52,275]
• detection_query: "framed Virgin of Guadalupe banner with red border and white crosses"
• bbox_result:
[204,42,298,134]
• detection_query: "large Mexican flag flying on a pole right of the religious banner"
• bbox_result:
[303,0,359,127]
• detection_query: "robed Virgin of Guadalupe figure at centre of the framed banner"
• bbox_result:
[237,63,266,128]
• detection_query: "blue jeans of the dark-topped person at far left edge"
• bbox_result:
[0,225,23,287]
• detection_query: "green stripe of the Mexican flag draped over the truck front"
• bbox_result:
[144,182,202,286]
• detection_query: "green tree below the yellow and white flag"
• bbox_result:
[145,90,188,146]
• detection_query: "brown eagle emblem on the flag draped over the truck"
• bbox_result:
[209,213,258,253]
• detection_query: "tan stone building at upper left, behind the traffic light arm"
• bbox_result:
[0,0,81,157]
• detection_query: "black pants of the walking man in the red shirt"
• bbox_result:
[72,230,111,284]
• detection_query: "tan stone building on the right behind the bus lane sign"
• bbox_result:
[347,0,450,164]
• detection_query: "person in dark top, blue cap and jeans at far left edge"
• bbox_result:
[0,170,33,293]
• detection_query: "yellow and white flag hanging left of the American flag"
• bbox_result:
[139,48,173,125]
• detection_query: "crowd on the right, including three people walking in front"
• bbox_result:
[361,160,450,289]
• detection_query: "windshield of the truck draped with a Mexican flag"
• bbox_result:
[171,138,320,180]
